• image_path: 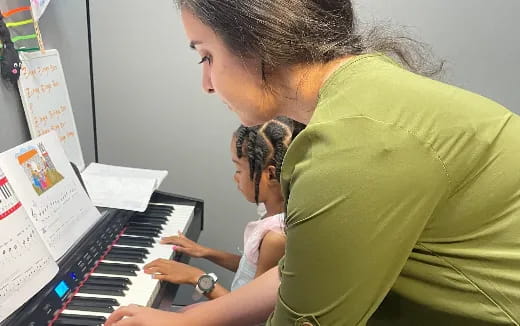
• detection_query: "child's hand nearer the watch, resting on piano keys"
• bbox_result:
[143,258,205,285]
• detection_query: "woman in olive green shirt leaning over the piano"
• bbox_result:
[107,0,520,326]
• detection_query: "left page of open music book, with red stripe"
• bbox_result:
[0,170,58,322]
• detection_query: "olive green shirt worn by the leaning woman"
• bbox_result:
[268,54,520,326]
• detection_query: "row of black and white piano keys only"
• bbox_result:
[54,203,193,326]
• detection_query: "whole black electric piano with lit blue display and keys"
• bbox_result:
[0,192,204,326]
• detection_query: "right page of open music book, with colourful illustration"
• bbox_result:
[0,131,101,260]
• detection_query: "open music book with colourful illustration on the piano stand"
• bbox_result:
[0,132,101,322]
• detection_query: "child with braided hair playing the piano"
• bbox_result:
[144,117,304,299]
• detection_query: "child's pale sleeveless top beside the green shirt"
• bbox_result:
[231,213,285,291]
